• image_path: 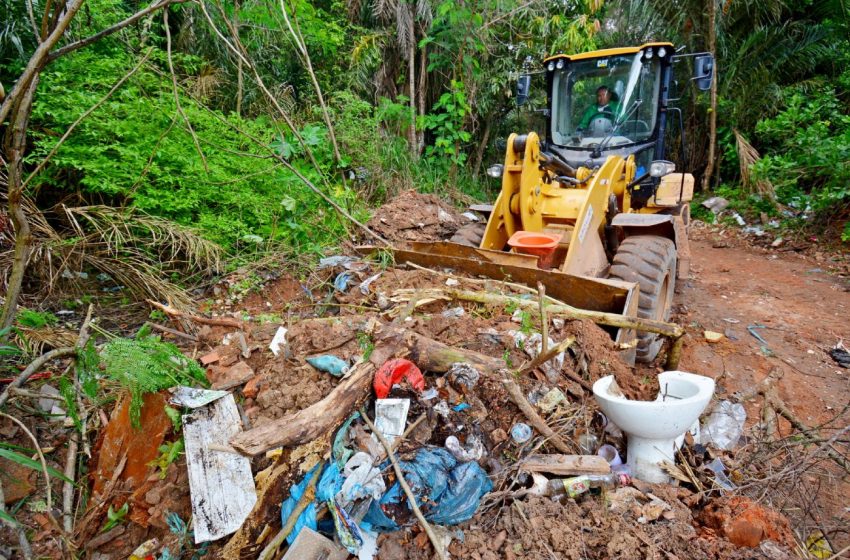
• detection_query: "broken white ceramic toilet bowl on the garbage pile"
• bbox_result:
[593,371,714,482]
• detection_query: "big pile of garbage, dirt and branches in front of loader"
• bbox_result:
[31,197,808,560]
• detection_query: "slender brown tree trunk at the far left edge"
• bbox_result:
[0,78,39,329]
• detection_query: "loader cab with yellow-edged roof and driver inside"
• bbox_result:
[544,43,674,176]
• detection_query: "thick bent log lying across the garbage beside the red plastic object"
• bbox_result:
[230,329,504,455]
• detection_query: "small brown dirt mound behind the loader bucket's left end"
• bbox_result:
[367,191,468,241]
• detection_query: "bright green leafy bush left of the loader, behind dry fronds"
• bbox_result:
[29,49,354,252]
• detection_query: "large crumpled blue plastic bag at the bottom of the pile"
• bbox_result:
[364,447,493,533]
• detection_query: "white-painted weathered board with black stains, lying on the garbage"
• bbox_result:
[183,395,257,543]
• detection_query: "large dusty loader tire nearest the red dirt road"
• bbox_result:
[608,235,676,364]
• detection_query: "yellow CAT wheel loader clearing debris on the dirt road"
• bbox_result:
[362,43,714,362]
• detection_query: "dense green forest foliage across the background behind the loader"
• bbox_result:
[0,0,850,272]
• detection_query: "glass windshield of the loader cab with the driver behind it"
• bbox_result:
[552,52,661,149]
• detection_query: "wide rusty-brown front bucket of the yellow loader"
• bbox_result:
[358,241,638,364]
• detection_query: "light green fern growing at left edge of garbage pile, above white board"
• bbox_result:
[95,336,207,428]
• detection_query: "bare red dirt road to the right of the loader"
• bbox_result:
[673,229,850,551]
